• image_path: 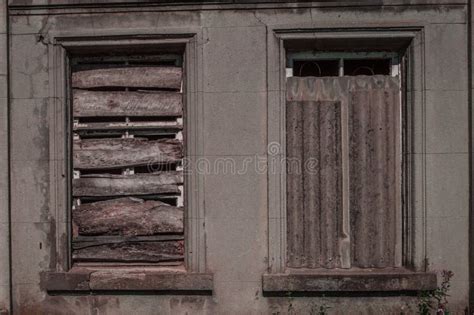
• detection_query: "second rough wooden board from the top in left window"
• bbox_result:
[73,89,183,117]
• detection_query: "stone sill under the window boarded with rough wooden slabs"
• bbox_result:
[42,268,213,295]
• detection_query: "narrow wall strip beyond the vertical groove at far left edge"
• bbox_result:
[0,0,10,313]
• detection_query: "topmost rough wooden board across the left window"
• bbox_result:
[72,67,182,90]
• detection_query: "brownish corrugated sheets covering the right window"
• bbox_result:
[286,75,401,269]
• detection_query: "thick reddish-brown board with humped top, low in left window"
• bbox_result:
[72,197,184,236]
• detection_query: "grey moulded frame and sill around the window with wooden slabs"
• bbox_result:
[42,33,213,294]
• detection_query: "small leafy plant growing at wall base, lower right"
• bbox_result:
[418,270,454,315]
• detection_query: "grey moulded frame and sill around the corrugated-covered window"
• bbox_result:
[262,25,436,292]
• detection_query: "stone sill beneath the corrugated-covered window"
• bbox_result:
[262,269,437,293]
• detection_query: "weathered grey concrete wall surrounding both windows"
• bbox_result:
[0,1,469,314]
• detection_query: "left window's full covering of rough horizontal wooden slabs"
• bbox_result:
[71,56,184,265]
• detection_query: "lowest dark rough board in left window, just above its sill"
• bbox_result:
[72,240,184,263]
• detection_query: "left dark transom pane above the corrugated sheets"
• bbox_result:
[293,60,339,77]
